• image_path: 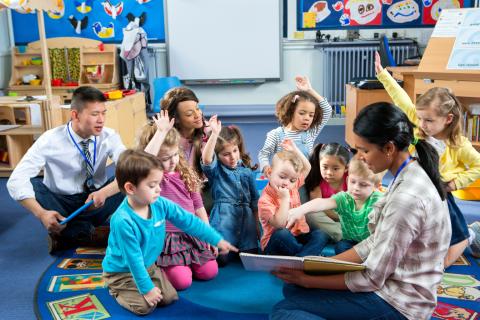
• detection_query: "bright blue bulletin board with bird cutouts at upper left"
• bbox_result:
[12,0,165,44]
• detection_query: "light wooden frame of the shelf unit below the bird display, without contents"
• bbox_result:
[8,37,119,104]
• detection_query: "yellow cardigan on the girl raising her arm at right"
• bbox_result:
[377,69,480,189]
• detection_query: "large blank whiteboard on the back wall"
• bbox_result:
[165,0,281,83]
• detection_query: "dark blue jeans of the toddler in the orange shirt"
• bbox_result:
[265,228,330,257]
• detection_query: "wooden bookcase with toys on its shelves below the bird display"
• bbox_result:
[8,37,119,103]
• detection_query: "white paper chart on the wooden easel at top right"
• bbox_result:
[446,9,480,70]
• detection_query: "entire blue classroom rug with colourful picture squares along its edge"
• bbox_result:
[35,249,480,320]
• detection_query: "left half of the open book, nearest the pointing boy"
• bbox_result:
[240,253,303,272]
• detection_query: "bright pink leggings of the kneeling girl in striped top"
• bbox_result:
[163,260,218,290]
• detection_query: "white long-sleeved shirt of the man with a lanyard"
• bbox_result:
[7,124,125,201]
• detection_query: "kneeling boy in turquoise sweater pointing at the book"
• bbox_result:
[102,150,238,315]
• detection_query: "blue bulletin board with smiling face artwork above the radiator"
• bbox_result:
[297,0,473,30]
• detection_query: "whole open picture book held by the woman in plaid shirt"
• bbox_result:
[240,253,365,274]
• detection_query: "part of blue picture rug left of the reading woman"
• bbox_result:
[35,249,282,320]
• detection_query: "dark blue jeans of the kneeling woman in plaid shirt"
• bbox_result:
[270,284,406,320]
